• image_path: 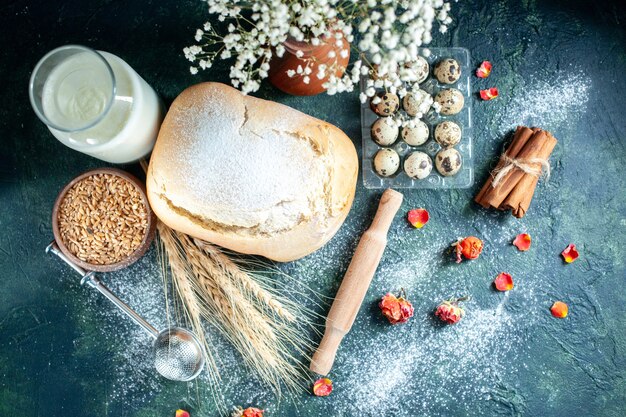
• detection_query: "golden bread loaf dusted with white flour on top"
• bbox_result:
[147,83,358,261]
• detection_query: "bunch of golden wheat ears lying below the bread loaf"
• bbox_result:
[158,222,311,396]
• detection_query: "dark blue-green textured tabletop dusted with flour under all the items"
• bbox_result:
[0,0,626,417]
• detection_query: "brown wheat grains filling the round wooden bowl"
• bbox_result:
[58,173,149,265]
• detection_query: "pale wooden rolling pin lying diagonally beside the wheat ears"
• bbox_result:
[309,189,403,375]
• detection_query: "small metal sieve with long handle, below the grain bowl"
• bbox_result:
[46,242,205,381]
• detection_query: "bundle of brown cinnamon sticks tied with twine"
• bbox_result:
[474,126,557,218]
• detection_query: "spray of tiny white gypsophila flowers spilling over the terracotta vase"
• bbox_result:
[183,0,452,94]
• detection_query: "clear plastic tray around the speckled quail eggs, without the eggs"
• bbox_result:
[360,48,474,189]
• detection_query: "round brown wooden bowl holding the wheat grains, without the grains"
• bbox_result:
[52,168,156,272]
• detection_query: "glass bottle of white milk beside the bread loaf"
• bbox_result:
[29,45,164,164]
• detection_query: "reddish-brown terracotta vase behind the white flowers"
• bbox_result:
[268,37,350,96]
